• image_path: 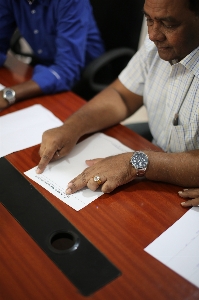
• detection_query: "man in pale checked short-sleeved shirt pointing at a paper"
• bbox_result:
[37,0,199,206]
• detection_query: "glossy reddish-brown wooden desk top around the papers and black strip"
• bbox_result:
[0,55,199,300]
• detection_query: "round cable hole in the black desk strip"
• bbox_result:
[50,231,79,252]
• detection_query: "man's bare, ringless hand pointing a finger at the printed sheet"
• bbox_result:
[36,125,78,174]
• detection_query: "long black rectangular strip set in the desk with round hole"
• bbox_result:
[0,158,121,296]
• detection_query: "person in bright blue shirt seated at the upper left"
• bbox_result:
[0,0,104,109]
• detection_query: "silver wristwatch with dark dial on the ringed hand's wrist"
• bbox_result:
[130,151,149,177]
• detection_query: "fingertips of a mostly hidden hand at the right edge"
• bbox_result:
[178,188,199,207]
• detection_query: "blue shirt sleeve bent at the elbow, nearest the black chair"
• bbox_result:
[32,0,104,93]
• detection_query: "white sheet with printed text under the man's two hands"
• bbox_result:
[24,133,132,211]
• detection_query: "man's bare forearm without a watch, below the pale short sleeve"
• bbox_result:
[64,80,142,136]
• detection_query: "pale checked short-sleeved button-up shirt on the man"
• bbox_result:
[119,37,199,152]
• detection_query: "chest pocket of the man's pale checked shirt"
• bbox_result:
[169,121,199,152]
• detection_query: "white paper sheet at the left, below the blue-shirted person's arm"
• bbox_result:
[0,104,62,157]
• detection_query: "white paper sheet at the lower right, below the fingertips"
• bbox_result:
[144,207,199,288]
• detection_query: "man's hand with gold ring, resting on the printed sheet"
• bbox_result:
[66,153,136,195]
